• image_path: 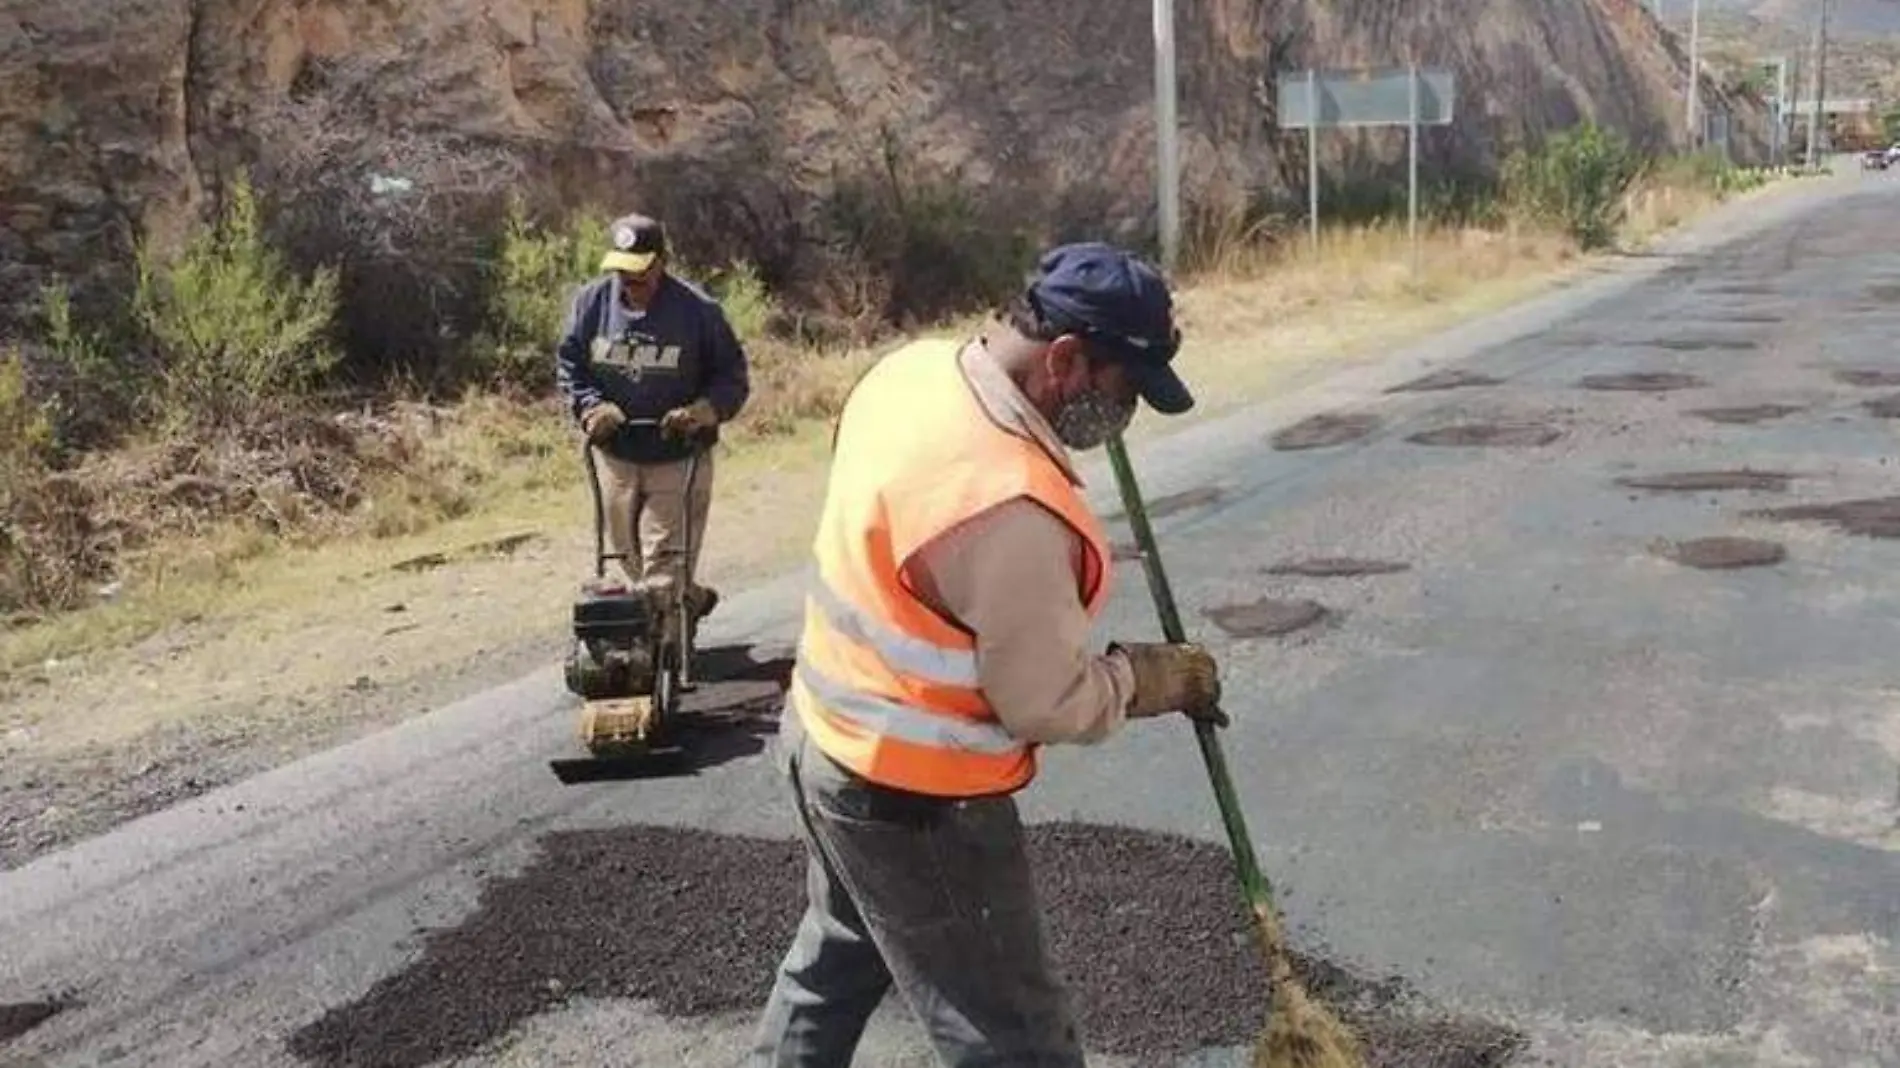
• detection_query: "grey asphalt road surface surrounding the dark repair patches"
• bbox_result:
[0,177,1900,1068]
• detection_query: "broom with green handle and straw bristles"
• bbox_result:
[1108,435,1366,1068]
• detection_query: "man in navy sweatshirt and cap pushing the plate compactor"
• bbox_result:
[557,215,751,618]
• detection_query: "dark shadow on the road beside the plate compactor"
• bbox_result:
[549,646,792,785]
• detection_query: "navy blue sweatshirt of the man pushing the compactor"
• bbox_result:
[555,272,751,464]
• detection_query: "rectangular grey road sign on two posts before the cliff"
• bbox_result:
[1279,63,1457,274]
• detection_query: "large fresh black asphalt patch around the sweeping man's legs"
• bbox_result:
[289,823,1524,1068]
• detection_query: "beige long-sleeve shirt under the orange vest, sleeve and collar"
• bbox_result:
[906,332,1134,743]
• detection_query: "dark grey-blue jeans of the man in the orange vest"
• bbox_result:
[749,709,1083,1068]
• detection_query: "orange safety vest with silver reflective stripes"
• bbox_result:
[790,340,1110,798]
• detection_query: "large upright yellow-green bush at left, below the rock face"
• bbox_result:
[133,181,336,428]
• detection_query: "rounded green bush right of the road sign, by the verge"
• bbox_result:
[1505,124,1642,249]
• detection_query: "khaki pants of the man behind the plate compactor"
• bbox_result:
[593,440,713,587]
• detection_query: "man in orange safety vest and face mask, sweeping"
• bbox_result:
[752,243,1222,1068]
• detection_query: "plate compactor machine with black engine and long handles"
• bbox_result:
[566,420,711,760]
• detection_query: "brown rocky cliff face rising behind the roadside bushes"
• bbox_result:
[0,0,1759,325]
